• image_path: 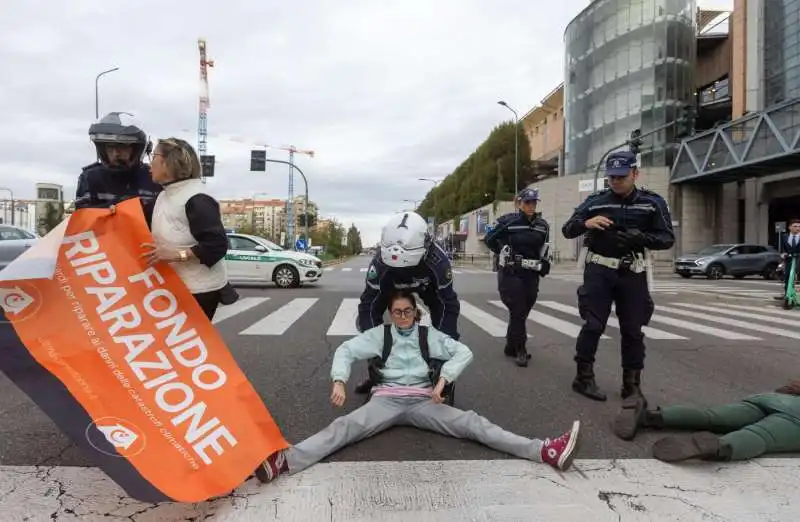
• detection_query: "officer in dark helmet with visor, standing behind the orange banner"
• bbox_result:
[75,112,161,210]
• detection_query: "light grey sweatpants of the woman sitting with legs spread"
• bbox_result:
[286,397,542,474]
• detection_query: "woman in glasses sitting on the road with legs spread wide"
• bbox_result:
[256,291,580,482]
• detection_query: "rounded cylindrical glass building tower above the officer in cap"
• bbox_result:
[564,0,700,175]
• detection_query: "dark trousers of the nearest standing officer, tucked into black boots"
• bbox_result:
[575,263,655,370]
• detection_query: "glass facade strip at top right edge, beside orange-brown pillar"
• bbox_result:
[764,0,800,107]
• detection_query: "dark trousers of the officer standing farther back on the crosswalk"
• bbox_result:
[497,267,539,348]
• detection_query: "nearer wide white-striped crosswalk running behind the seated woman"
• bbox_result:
[213,296,800,342]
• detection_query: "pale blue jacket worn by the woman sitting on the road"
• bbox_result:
[331,325,472,387]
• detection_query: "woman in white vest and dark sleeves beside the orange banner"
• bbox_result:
[143,138,235,319]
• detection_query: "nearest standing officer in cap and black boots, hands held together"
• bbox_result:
[562,152,675,438]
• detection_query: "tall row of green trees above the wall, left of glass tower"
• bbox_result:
[417,122,535,223]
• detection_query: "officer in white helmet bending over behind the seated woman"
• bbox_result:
[356,212,461,393]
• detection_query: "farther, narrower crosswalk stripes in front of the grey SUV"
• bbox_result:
[550,274,781,299]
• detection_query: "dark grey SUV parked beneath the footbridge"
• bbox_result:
[674,243,781,279]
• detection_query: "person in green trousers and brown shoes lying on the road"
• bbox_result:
[612,381,800,462]
